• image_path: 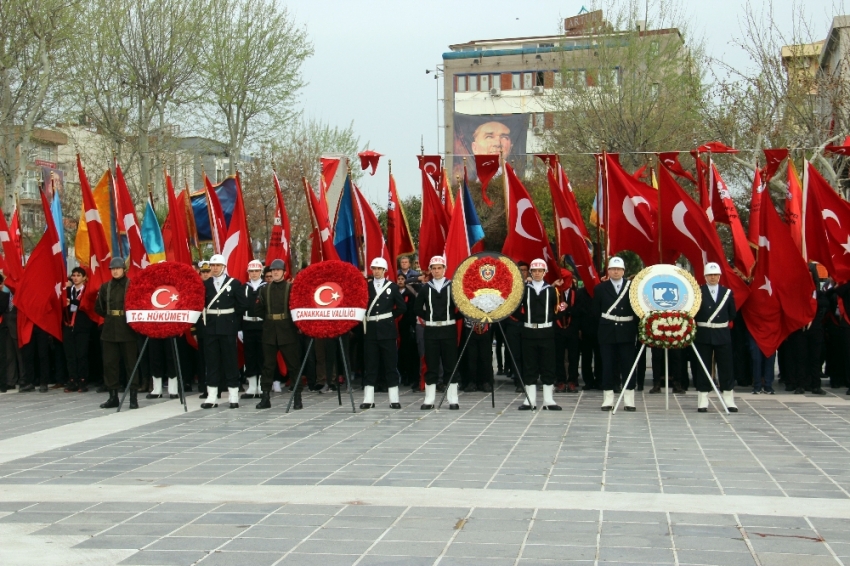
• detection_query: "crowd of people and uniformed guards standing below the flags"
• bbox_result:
[0,255,850,412]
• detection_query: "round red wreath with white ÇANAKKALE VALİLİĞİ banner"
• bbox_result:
[289,260,369,338]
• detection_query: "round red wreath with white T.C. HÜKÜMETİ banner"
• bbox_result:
[124,261,205,338]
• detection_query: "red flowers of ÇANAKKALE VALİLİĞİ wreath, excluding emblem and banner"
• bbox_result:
[289,260,369,338]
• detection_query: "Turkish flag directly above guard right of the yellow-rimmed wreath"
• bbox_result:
[502,163,561,282]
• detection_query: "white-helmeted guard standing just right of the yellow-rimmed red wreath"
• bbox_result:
[519,259,563,411]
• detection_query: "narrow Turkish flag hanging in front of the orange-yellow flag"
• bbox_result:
[77,154,112,324]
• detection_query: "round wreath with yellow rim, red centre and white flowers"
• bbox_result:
[452,252,525,322]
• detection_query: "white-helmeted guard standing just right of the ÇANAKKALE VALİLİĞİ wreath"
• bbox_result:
[360,257,407,409]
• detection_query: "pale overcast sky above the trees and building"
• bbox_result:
[287,0,847,207]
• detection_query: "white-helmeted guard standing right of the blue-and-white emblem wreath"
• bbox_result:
[694,262,738,413]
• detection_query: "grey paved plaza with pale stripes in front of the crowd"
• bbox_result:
[0,378,850,566]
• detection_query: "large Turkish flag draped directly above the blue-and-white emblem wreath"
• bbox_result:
[658,167,749,308]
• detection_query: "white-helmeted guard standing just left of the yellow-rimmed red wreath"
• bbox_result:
[414,255,460,411]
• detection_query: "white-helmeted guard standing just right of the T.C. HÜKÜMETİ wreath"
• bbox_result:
[201,254,247,409]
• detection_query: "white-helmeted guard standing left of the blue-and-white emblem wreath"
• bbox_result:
[593,257,637,411]
